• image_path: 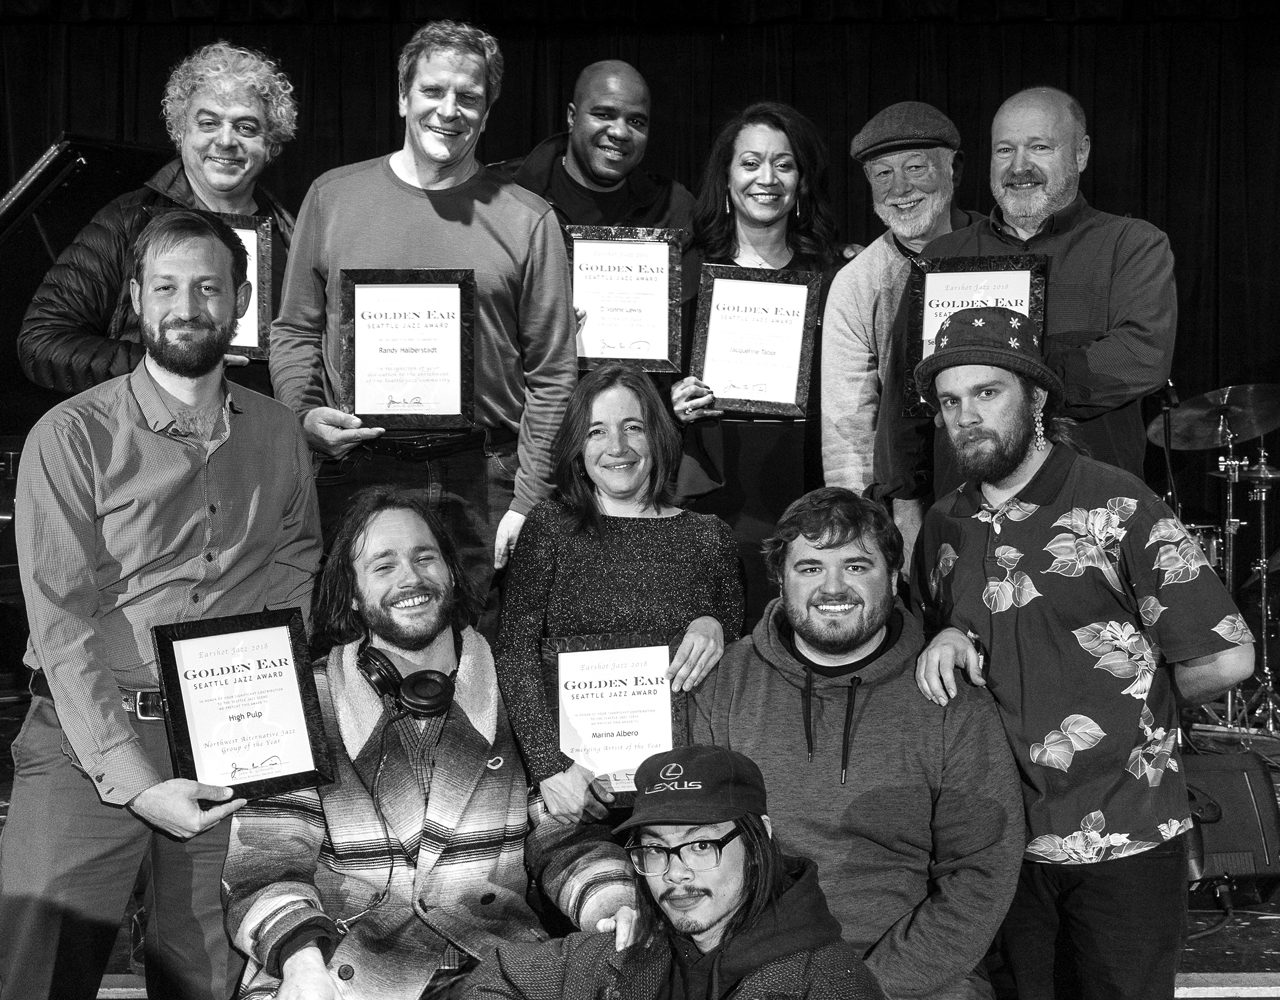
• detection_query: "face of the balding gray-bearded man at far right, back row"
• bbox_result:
[991,92,1089,233]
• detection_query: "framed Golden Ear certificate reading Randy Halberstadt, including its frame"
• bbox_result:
[338,269,476,430]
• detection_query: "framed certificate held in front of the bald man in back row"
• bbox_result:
[564,225,681,371]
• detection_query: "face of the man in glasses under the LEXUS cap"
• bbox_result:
[637,821,746,954]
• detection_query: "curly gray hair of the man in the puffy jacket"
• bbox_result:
[163,41,298,160]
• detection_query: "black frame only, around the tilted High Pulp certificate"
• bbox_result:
[151,608,333,799]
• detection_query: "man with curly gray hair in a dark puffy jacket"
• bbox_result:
[18,41,298,394]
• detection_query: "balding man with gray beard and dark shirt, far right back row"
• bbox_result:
[926,87,1178,497]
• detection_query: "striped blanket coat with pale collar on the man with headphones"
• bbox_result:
[223,629,634,1000]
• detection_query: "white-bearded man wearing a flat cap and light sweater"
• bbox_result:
[822,101,982,561]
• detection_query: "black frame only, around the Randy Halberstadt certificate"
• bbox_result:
[338,268,476,430]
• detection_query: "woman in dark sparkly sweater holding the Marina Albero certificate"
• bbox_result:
[495,364,742,822]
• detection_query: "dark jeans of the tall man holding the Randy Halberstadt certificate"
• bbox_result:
[316,442,520,643]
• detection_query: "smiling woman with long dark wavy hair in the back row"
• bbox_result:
[671,101,844,629]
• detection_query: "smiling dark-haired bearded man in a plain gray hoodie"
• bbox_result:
[694,488,1025,1000]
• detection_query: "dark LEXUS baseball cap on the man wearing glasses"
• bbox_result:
[613,745,768,834]
